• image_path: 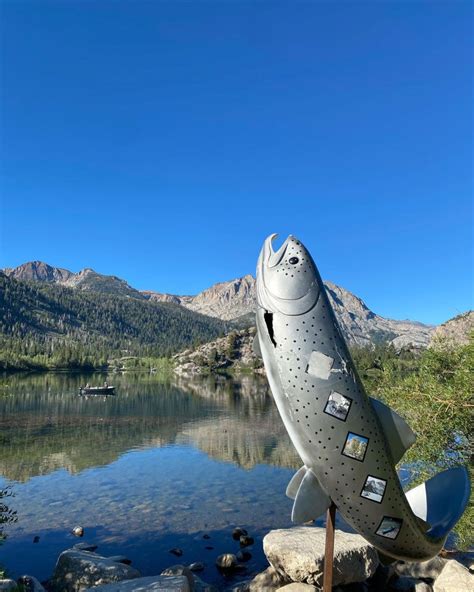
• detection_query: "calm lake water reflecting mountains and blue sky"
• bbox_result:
[0,373,300,586]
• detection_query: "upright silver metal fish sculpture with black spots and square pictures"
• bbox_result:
[254,235,470,561]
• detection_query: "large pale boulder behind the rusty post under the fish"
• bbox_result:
[263,526,379,587]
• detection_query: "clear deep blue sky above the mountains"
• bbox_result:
[0,0,473,323]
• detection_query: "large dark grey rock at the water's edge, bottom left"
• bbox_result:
[50,549,140,592]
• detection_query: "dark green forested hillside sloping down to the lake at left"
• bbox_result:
[0,274,224,367]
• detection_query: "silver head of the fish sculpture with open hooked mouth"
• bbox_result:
[257,234,321,316]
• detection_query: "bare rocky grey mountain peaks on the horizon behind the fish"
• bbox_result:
[3,261,434,349]
